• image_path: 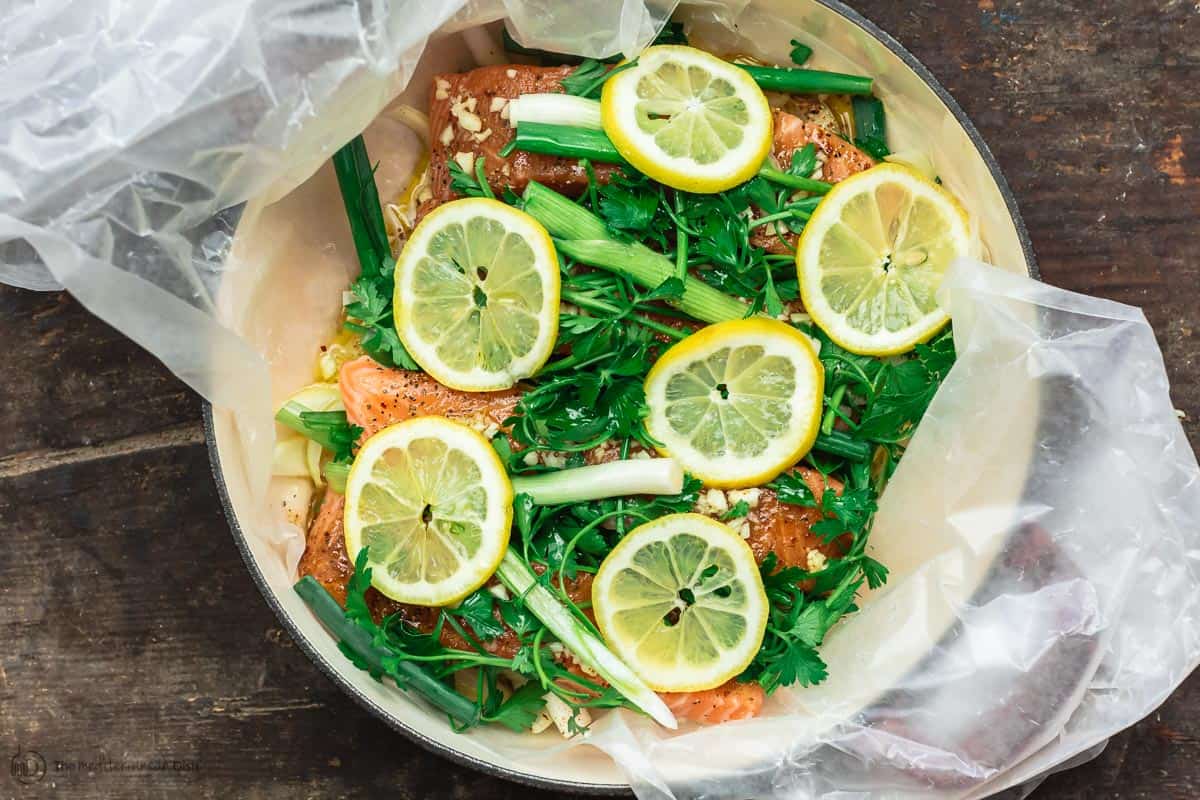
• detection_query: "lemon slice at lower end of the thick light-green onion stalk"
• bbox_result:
[646,318,824,488]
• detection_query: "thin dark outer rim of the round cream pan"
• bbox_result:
[202,0,1040,796]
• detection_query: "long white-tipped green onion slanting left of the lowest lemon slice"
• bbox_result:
[496,547,678,730]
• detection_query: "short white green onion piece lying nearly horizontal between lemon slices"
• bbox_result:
[512,458,683,505]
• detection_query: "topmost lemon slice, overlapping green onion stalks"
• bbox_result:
[600,44,772,193]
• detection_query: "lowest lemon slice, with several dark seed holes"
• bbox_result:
[592,513,768,692]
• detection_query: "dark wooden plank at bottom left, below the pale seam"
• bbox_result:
[0,445,566,800]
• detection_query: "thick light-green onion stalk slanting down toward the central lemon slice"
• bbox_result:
[524,181,748,323]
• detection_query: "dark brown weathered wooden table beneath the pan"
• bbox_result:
[0,0,1200,800]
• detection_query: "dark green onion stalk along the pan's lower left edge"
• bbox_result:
[293,575,479,726]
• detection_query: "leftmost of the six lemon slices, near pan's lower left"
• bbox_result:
[346,416,512,606]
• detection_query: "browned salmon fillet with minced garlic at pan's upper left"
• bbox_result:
[418,64,617,217]
